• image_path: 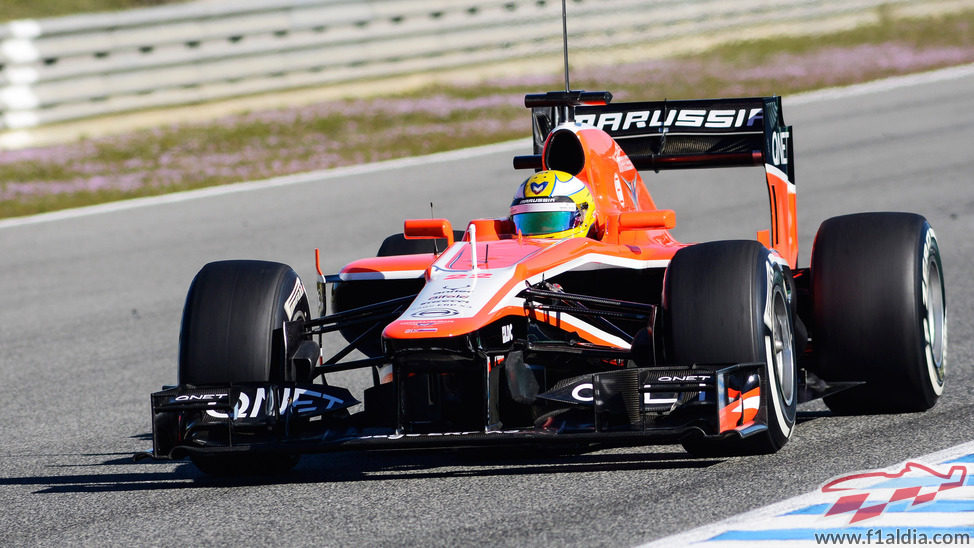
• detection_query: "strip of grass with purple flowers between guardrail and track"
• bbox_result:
[0,12,974,217]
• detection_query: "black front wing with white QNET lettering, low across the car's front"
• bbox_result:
[151,363,767,458]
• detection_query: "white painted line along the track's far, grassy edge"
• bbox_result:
[0,64,974,229]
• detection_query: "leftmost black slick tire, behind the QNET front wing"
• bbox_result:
[179,260,310,475]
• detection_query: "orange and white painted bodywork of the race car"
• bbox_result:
[339,124,798,348]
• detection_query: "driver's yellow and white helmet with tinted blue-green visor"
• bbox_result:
[511,170,595,238]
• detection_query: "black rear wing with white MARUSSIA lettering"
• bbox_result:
[515,91,795,184]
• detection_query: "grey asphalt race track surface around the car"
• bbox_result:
[0,67,974,546]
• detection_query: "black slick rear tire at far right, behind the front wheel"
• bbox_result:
[811,212,947,414]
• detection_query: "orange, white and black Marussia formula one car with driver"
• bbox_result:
[151,91,947,473]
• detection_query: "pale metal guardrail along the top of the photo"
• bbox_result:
[0,0,940,130]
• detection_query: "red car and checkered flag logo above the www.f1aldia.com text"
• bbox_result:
[822,462,967,524]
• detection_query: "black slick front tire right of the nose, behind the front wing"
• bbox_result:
[663,240,798,456]
